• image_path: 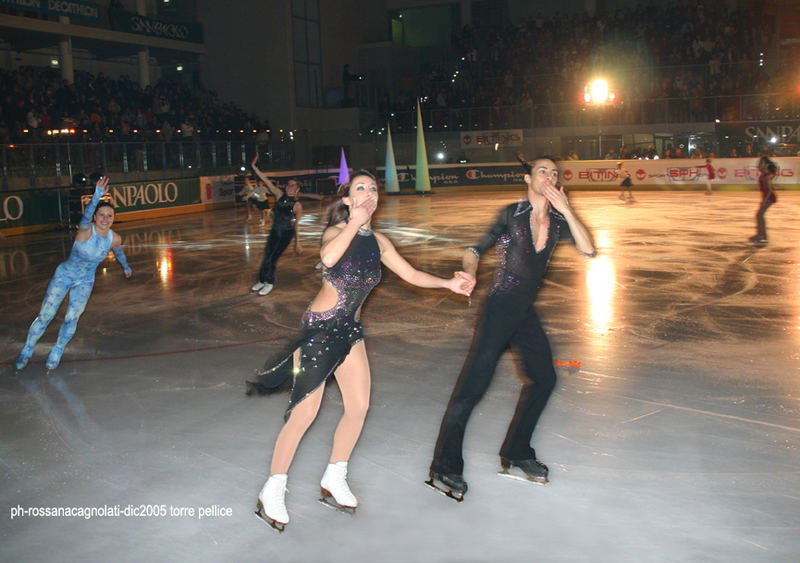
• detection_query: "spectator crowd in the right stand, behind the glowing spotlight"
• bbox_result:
[383,0,800,127]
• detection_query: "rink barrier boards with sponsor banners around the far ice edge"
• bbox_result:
[0,157,800,236]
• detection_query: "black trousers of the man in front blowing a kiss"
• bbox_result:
[431,290,556,474]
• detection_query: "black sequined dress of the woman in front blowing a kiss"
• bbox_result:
[250,230,381,420]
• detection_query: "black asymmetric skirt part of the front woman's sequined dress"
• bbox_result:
[247,312,364,420]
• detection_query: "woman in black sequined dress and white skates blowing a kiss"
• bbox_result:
[247,170,475,531]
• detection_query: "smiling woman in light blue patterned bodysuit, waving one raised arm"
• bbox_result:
[14,177,132,370]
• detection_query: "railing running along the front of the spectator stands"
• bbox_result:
[6,93,800,190]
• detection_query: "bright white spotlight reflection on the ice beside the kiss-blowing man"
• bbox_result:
[586,231,616,346]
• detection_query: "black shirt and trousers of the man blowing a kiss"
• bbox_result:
[431,199,572,475]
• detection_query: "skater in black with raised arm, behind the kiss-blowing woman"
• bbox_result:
[250,155,322,295]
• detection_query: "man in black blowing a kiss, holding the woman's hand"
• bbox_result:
[427,157,595,500]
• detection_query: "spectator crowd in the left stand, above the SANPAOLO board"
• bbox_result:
[0,67,269,143]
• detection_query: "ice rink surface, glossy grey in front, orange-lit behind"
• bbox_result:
[0,188,800,563]
